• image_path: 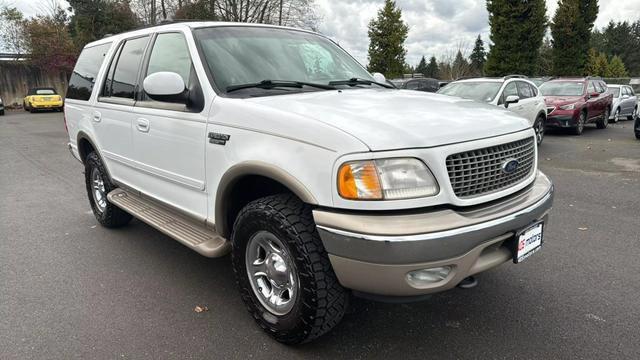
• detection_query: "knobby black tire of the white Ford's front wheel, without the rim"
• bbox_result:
[231,194,349,344]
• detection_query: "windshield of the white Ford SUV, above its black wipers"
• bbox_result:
[194,26,373,92]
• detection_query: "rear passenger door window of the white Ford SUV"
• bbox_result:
[111,37,149,99]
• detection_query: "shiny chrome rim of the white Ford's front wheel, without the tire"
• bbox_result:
[245,231,299,315]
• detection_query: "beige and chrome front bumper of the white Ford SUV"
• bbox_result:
[313,173,554,296]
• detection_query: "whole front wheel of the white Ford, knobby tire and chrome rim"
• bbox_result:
[232,195,348,344]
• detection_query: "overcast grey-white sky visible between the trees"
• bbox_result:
[5,0,640,65]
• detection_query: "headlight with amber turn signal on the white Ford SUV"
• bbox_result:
[338,158,440,200]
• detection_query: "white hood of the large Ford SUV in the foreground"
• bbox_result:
[246,89,529,151]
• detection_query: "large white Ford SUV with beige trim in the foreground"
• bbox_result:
[65,22,553,344]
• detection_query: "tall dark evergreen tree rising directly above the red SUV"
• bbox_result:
[551,0,598,75]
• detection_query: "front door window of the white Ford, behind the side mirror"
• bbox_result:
[147,33,191,87]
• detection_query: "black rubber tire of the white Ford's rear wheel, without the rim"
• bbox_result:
[84,152,132,228]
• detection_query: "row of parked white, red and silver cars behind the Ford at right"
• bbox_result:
[438,75,639,144]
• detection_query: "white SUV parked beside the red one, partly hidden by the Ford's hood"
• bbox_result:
[438,75,547,145]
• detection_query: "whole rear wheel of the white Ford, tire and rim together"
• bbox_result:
[84,152,132,228]
